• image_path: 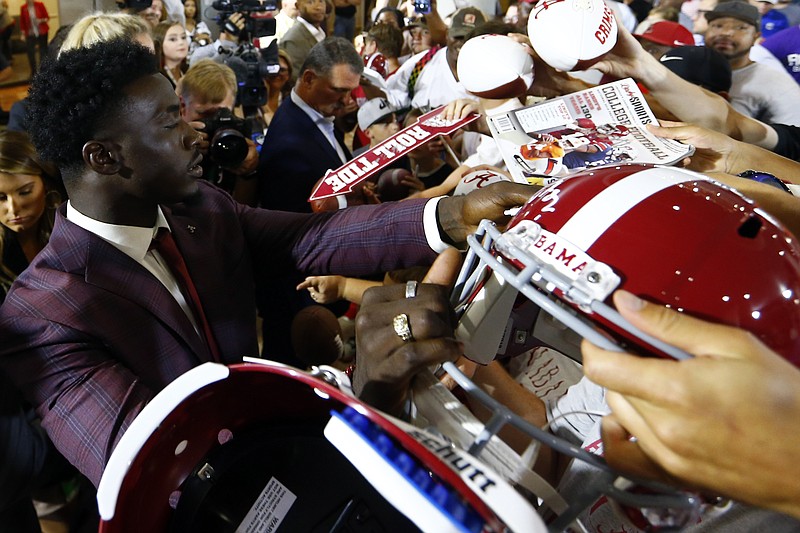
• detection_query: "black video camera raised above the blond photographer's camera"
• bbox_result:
[211,0,280,114]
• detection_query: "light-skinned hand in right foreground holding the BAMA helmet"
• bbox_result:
[582,291,800,517]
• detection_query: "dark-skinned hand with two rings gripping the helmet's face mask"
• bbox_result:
[353,249,462,415]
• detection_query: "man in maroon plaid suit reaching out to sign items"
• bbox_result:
[0,41,531,483]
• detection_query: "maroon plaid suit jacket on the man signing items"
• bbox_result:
[0,183,435,484]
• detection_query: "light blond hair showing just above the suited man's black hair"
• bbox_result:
[61,11,150,55]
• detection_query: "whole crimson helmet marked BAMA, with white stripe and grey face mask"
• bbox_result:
[444,165,800,530]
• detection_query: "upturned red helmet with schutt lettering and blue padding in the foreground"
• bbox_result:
[97,359,545,533]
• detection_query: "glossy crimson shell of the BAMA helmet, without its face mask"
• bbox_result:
[455,165,800,365]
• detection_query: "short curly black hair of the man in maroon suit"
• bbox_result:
[28,39,159,178]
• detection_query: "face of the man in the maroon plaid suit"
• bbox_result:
[114,74,203,207]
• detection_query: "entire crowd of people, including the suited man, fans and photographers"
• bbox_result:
[0,0,800,531]
